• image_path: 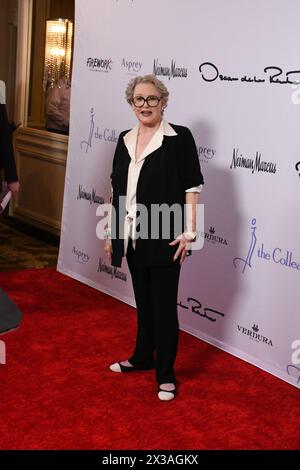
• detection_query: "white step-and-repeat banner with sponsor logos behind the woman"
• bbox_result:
[58,0,300,388]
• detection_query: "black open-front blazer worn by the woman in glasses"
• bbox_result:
[111,124,203,267]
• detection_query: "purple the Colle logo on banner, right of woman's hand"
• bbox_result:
[233,219,300,274]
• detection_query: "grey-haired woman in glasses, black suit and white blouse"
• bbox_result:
[104,75,203,400]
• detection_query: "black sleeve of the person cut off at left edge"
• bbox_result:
[0,104,18,183]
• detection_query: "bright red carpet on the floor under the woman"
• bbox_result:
[0,269,300,450]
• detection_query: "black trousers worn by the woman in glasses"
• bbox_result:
[127,239,180,384]
